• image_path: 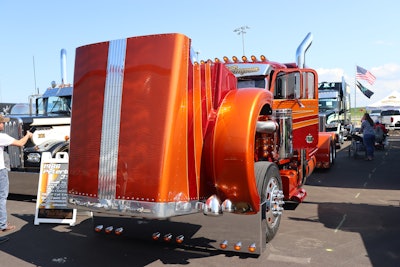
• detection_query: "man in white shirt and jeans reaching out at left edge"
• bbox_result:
[0,115,32,232]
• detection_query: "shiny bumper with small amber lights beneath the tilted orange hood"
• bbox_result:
[93,205,266,255]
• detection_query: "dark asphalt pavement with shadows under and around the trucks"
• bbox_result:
[0,136,400,267]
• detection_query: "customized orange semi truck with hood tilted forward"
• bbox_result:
[68,33,335,254]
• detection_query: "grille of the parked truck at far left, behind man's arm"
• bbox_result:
[4,118,24,169]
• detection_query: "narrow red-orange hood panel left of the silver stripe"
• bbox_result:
[68,42,108,196]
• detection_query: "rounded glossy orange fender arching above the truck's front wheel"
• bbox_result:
[211,89,272,211]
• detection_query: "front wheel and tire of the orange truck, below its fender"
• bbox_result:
[254,161,284,243]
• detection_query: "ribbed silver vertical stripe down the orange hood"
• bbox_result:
[98,39,126,199]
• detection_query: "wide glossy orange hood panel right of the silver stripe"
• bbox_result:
[117,34,189,202]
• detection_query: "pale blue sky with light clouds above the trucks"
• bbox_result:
[0,0,400,106]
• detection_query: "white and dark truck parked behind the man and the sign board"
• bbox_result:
[4,49,73,195]
